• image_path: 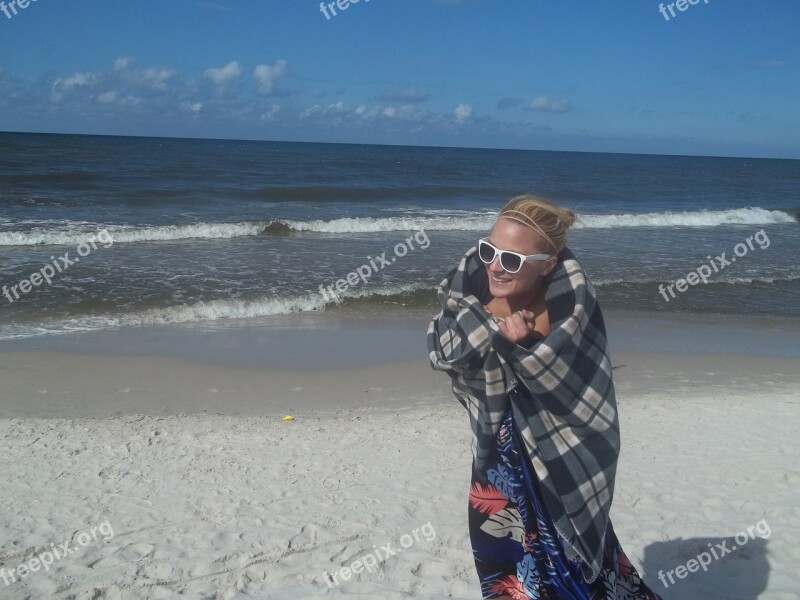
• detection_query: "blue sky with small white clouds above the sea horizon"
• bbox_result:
[0,0,800,158]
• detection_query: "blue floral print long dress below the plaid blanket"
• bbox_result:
[469,407,660,600]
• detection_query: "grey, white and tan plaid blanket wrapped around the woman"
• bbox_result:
[427,247,620,582]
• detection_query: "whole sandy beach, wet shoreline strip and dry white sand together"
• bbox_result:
[0,315,800,600]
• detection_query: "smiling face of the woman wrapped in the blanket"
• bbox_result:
[484,217,557,299]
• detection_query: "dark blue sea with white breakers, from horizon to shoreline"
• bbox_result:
[0,133,800,340]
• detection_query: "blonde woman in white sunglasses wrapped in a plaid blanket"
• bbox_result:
[428,196,659,600]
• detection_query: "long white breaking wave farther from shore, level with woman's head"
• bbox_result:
[0,207,797,246]
